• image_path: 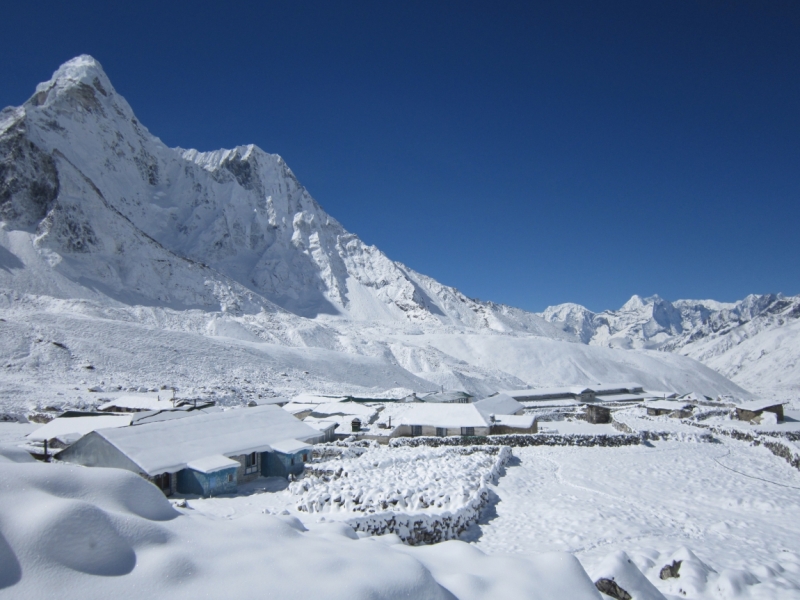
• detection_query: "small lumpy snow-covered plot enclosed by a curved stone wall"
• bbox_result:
[290,446,511,545]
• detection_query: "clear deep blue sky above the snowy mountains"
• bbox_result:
[0,0,800,311]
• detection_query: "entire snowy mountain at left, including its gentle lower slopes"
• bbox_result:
[0,56,747,405]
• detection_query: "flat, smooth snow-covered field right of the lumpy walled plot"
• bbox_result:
[471,440,800,599]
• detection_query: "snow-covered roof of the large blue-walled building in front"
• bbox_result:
[66,406,320,475]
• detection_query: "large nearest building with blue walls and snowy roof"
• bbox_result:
[56,406,324,496]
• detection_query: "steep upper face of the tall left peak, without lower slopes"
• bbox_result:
[0,55,563,338]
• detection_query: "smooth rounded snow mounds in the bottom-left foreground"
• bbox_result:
[0,449,598,600]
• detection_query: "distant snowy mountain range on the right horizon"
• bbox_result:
[541,294,800,398]
